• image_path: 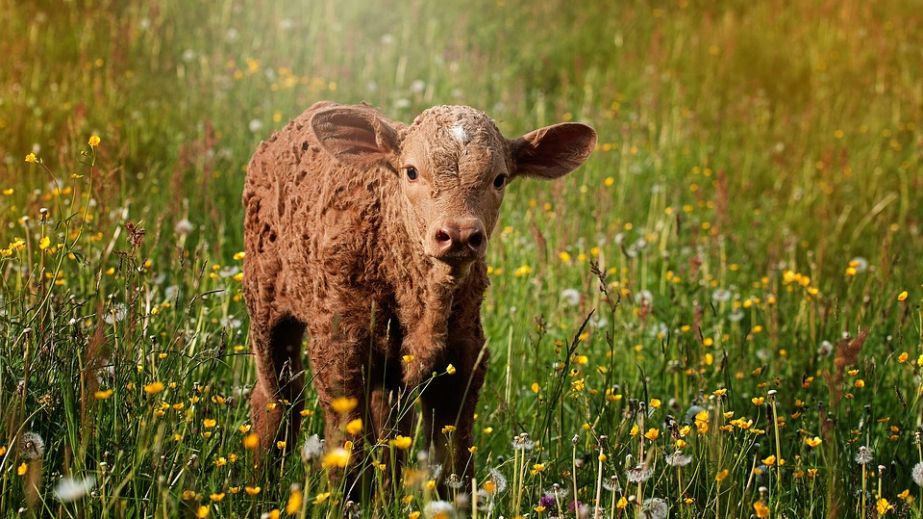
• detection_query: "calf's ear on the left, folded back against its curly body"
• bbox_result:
[311,106,400,169]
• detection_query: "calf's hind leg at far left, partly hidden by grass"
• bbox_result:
[250,315,305,450]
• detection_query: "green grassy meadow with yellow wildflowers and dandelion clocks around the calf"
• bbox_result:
[0,0,923,519]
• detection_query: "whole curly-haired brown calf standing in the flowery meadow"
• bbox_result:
[243,102,596,494]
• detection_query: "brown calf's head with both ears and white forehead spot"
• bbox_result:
[311,106,596,266]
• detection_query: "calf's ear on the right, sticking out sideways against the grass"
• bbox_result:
[510,123,596,179]
